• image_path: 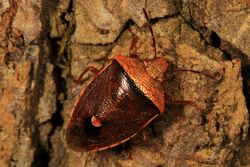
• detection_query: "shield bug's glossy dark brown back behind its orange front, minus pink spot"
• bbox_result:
[67,61,160,151]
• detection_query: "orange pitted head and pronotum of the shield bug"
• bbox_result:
[113,56,168,113]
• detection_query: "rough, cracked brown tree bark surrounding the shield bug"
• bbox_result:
[0,0,250,167]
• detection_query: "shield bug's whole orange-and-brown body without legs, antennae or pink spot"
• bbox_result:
[66,56,168,151]
